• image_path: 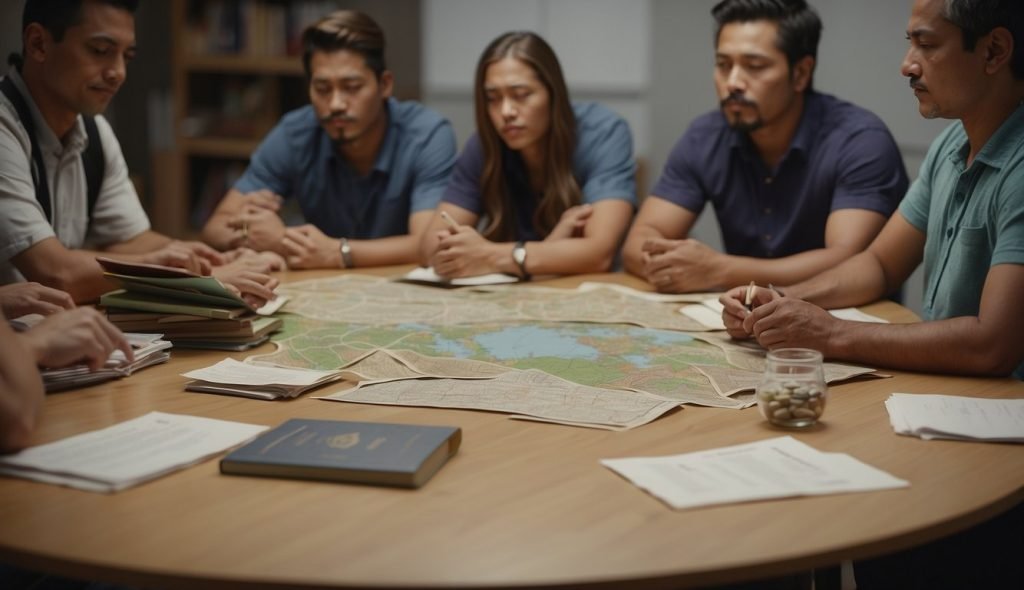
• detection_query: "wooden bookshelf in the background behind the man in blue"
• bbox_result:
[161,0,420,238]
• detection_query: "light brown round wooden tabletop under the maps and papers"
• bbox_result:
[0,269,1024,588]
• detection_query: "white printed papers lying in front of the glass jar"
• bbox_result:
[601,436,909,510]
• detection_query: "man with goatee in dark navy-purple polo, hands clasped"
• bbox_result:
[623,0,908,293]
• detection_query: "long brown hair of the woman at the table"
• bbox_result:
[474,32,582,242]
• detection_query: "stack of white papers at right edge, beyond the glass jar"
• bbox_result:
[886,393,1024,443]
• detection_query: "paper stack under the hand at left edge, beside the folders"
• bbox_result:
[41,333,172,392]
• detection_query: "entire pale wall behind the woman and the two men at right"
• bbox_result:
[423,0,933,309]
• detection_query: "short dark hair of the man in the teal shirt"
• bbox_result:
[942,0,1024,80]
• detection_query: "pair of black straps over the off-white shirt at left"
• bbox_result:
[0,77,106,224]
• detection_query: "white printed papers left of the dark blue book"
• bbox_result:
[0,412,267,492]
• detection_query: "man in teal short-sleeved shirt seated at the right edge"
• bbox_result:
[722,0,1024,379]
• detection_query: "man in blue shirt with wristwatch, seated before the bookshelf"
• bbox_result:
[203,10,456,268]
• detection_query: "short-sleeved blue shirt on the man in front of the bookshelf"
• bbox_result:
[234,98,456,240]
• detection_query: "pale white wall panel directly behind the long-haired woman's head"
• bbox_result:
[423,0,651,170]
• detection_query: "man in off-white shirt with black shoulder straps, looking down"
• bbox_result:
[0,0,276,303]
